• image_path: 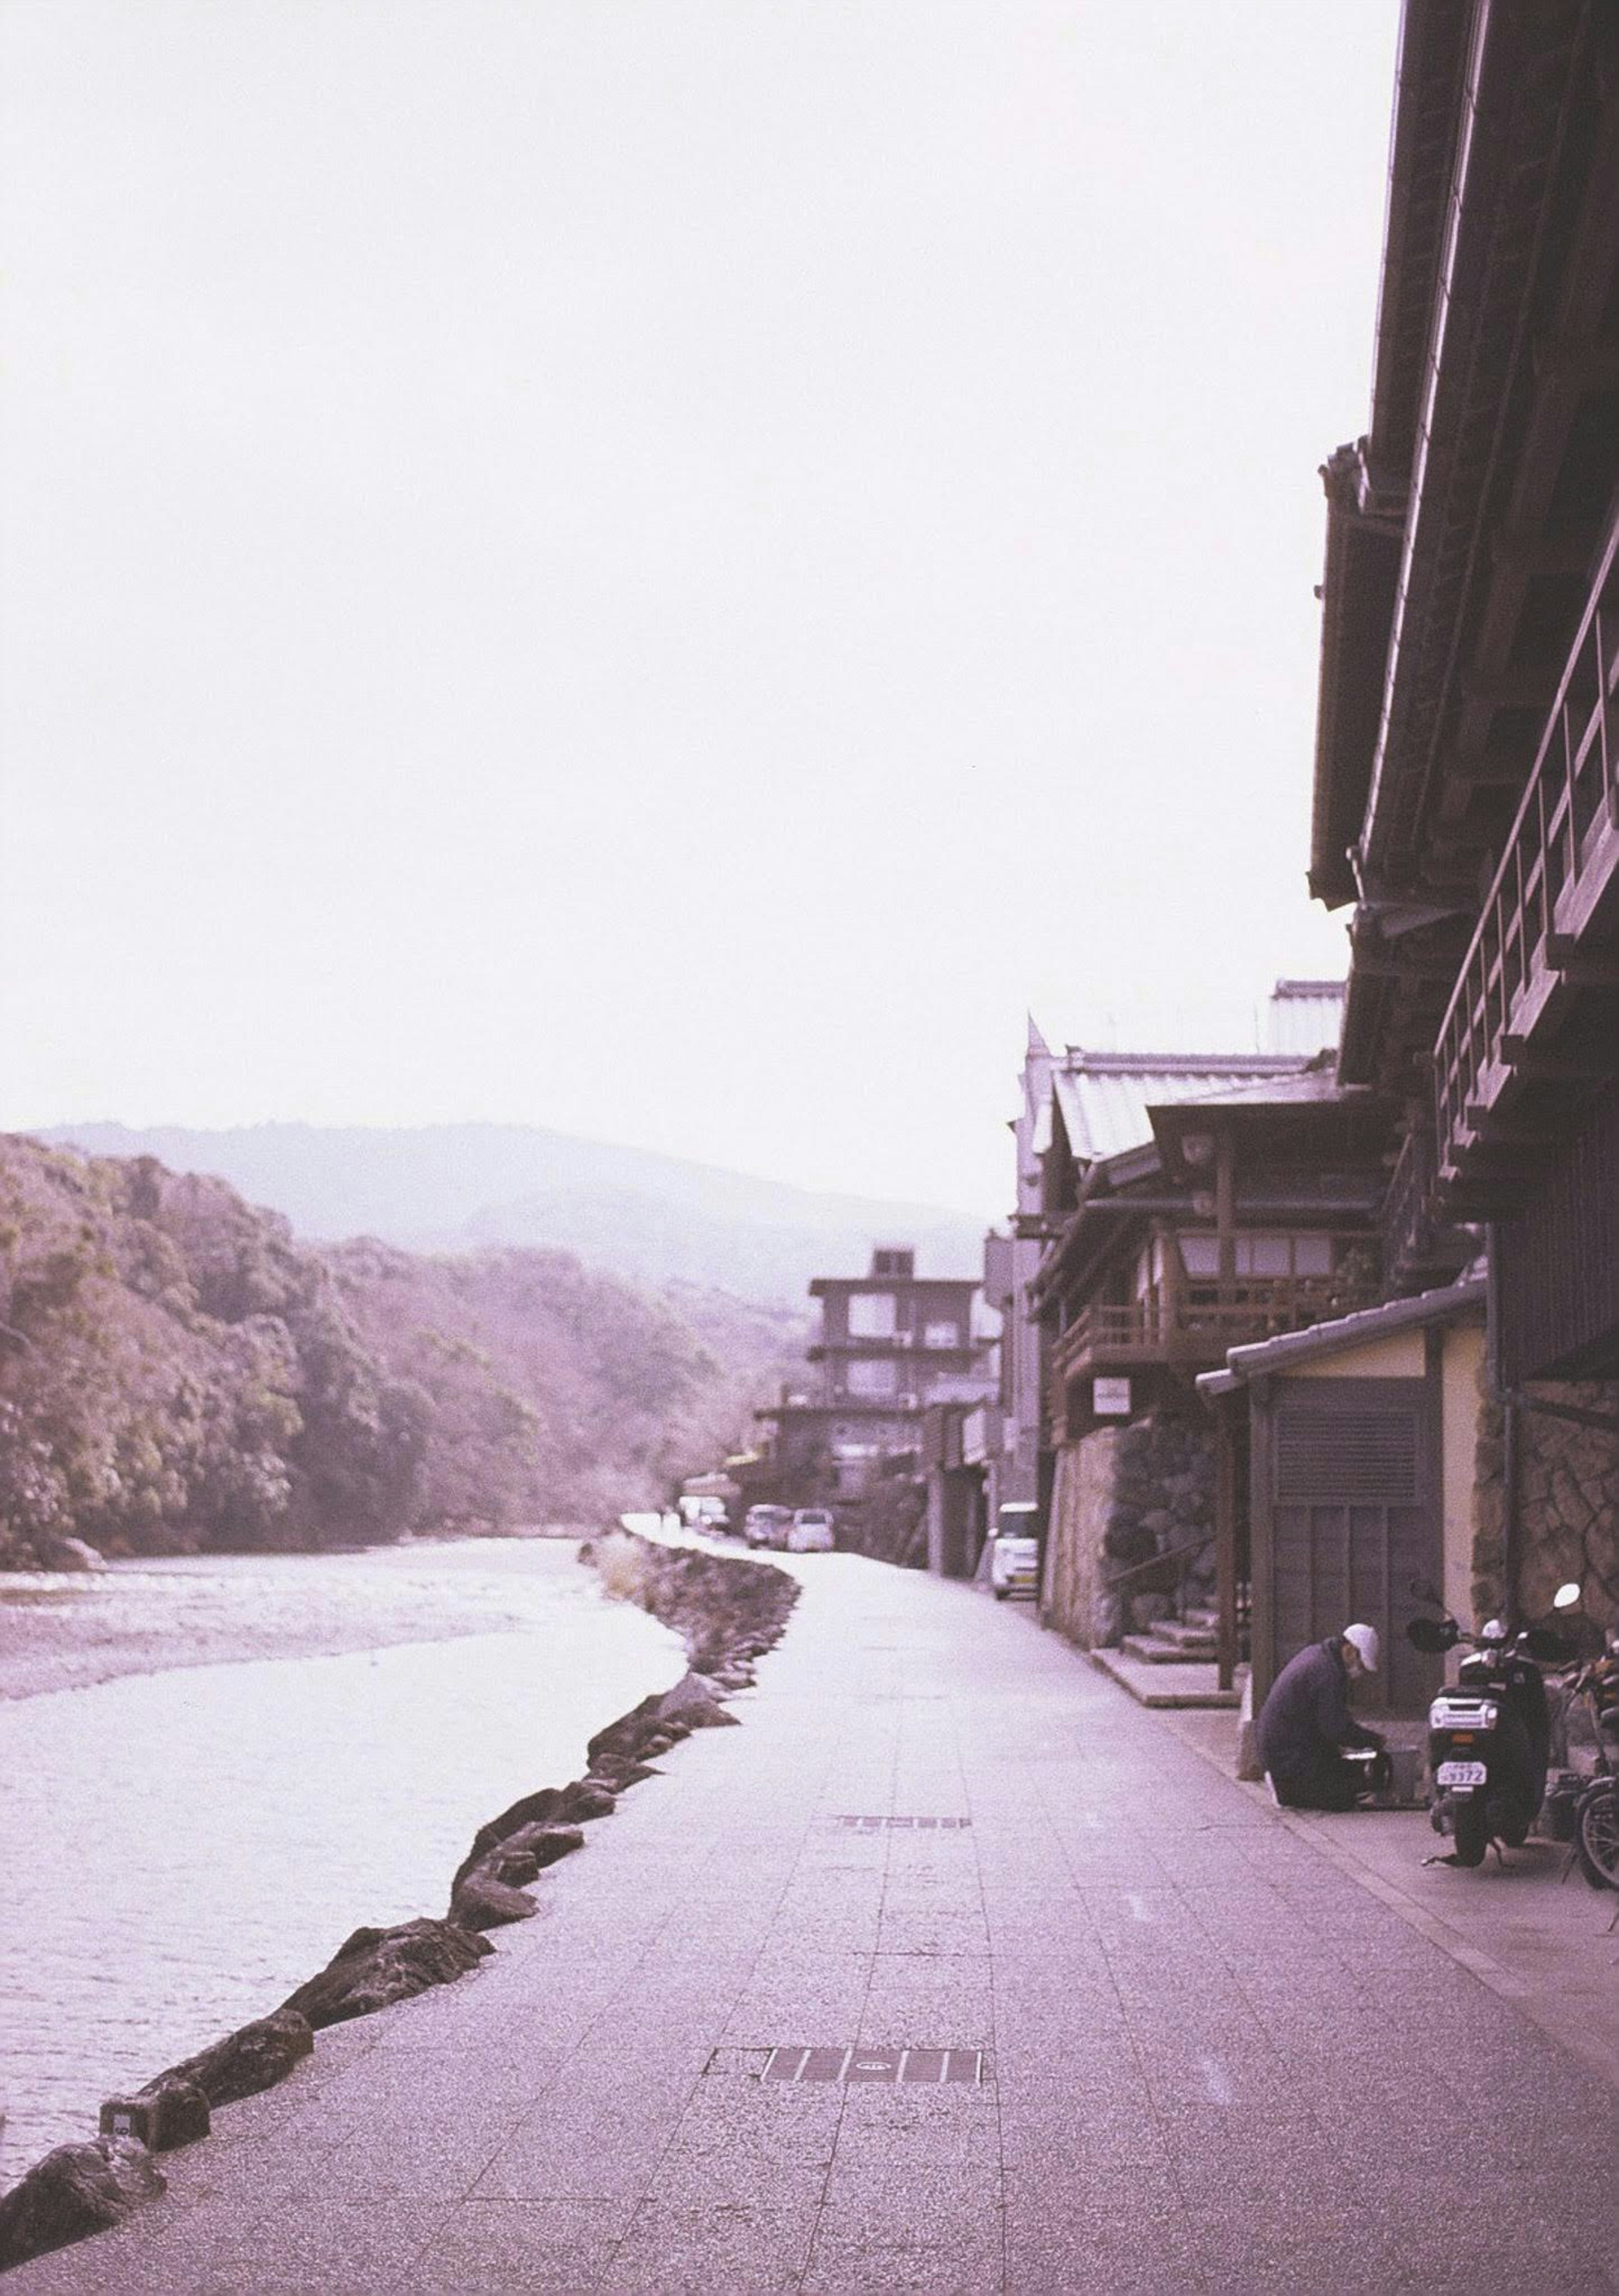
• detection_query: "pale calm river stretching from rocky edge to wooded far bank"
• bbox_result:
[0,1538,684,2190]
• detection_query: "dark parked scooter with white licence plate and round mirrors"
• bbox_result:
[1405,1582,1580,1867]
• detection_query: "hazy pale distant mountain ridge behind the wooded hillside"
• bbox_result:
[35,1123,983,1304]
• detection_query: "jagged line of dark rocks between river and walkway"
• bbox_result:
[0,1529,799,2271]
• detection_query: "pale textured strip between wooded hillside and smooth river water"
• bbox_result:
[0,1527,583,1699]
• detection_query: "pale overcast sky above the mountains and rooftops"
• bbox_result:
[0,0,1396,1212]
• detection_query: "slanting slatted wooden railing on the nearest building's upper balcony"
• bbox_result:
[1433,514,1619,1191]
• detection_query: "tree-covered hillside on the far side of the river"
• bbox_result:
[0,1137,804,1566]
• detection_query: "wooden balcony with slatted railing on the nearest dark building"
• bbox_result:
[1433,514,1619,1219]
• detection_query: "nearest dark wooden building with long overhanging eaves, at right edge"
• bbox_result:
[1304,0,1619,1658]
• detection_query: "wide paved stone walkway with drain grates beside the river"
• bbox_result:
[7,1557,1619,2296]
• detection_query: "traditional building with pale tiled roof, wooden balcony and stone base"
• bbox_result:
[1022,983,1389,1658]
